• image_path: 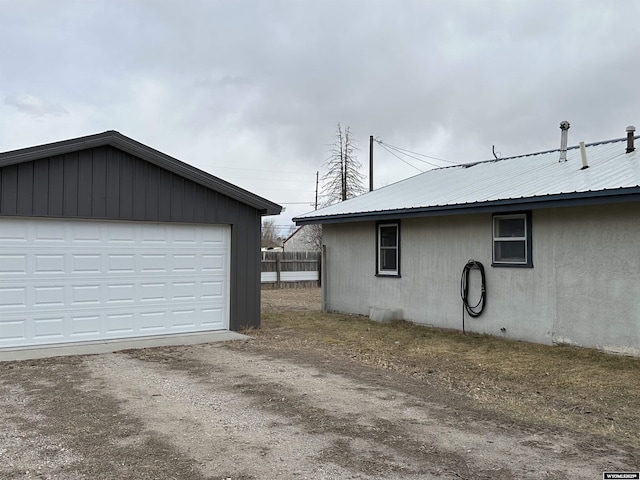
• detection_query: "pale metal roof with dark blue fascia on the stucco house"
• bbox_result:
[293,137,640,225]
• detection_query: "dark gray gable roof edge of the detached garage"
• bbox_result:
[0,130,282,215]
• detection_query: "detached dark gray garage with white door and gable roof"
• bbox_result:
[0,131,281,350]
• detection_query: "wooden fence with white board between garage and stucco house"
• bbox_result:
[260,252,320,288]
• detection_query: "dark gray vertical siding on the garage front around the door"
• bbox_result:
[0,146,261,330]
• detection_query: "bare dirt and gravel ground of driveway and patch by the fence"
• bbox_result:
[0,290,640,480]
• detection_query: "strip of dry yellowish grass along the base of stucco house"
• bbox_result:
[256,291,640,448]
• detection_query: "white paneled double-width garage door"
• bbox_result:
[0,217,230,348]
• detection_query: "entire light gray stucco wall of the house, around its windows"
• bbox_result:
[323,204,640,354]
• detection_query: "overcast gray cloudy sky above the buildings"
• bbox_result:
[0,0,640,229]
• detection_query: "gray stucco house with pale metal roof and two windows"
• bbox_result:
[294,122,640,355]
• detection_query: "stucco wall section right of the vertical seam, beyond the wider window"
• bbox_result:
[553,204,640,355]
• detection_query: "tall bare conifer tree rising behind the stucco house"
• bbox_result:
[322,123,365,205]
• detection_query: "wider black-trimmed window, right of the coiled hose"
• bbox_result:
[492,212,533,267]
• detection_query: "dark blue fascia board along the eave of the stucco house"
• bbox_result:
[293,187,640,225]
